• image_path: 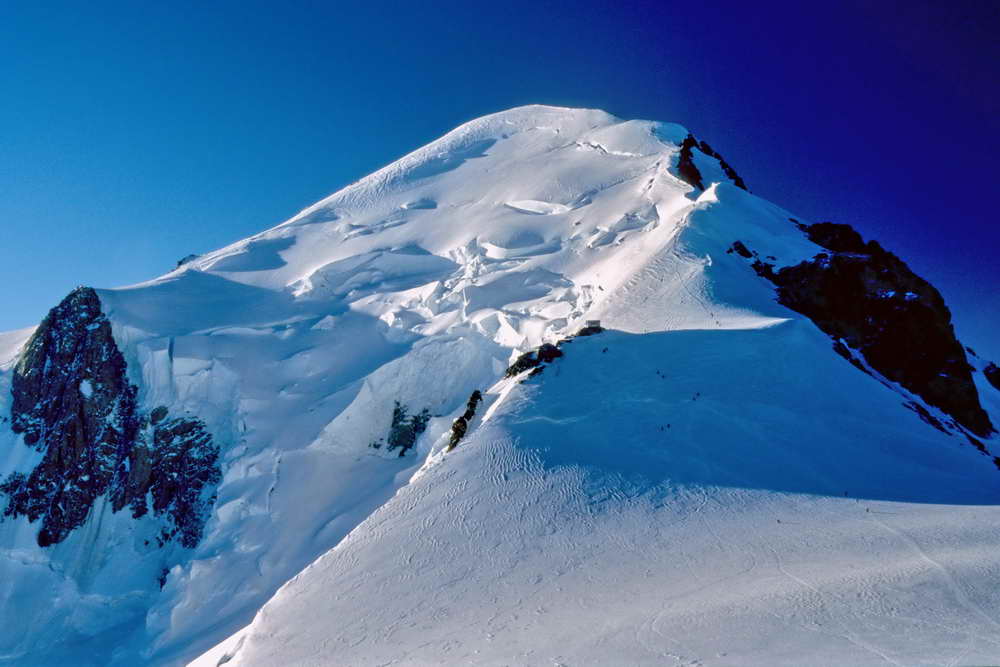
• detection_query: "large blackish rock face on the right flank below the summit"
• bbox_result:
[740,222,994,436]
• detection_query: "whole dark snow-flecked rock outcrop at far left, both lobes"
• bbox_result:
[0,287,220,547]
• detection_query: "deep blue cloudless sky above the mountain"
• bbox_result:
[0,0,1000,358]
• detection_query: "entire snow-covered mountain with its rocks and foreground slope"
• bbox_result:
[0,106,1000,665]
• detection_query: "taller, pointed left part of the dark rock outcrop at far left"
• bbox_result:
[0,287,141,546]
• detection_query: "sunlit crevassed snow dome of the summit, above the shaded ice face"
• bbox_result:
[166,107,780,348]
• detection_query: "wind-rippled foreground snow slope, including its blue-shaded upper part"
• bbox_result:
[207,330,1000,667]
